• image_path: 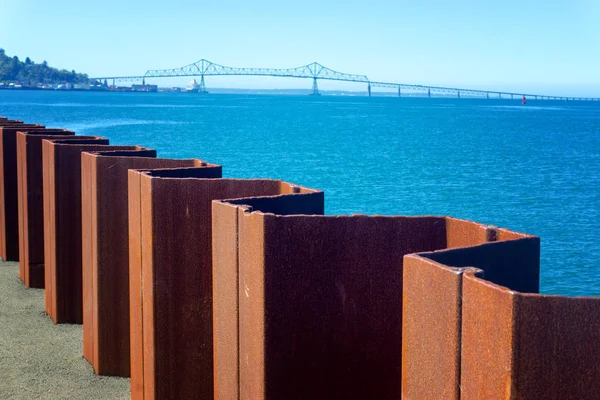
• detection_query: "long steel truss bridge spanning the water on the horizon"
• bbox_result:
[92,59,600,101]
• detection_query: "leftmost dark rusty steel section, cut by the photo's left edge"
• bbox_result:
[0,125,45,261]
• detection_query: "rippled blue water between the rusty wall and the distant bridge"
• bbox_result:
[0,91,600,296]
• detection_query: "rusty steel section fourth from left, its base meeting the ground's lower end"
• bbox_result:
[81,148,217,376]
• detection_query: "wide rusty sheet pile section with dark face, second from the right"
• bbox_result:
[213,199,502,399]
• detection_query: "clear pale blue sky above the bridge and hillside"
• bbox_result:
[0,0,600,97]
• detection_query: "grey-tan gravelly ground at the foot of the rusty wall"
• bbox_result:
[0,259,130,400]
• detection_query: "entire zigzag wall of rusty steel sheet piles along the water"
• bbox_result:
[0,113,600,400]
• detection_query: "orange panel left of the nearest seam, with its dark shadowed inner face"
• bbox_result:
[402,231,539,399]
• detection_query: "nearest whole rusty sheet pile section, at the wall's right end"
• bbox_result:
[402,228,600,400]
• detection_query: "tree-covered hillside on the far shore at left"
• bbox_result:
[0,49,88,86]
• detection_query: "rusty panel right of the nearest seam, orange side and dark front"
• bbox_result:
[461,273,600,400]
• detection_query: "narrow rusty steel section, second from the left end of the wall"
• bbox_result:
[17,129,75,288]
